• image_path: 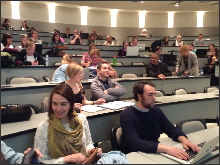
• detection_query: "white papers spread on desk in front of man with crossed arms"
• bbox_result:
[99,101,134,110]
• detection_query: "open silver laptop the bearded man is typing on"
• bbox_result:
[161,136,219,164]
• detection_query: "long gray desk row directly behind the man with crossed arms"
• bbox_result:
[1,76,210,107]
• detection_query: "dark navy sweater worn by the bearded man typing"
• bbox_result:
[120,106,186,154]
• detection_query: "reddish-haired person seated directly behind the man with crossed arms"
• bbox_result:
[86,49,117,78]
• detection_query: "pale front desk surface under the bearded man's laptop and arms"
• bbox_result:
[127,127,219,164]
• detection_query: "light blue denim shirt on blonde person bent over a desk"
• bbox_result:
[52,64,69,82]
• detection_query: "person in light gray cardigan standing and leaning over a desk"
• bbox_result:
[175,45,199,76]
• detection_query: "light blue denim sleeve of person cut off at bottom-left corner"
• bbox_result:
[1,141,24,164]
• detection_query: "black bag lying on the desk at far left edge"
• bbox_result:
[1,106,32,123]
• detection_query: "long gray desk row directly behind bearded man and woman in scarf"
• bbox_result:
[1,93,219,152]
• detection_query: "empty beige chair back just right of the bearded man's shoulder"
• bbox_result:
[176,118,207,134]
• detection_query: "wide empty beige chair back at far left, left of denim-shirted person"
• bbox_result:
[6,76,39,84]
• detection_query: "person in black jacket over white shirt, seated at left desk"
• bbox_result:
[15,41,46,65]
